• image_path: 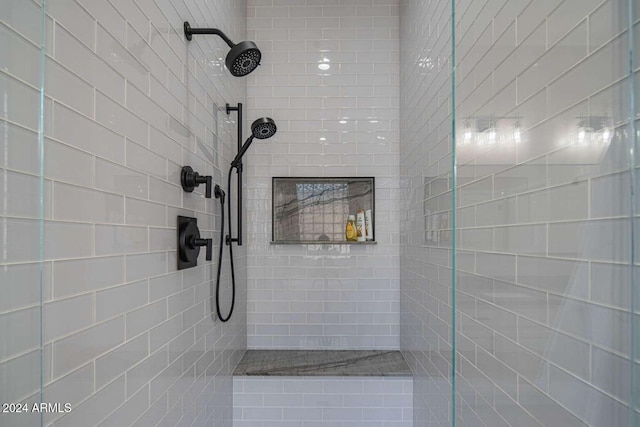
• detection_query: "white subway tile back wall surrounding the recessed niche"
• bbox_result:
[245,0,399,349]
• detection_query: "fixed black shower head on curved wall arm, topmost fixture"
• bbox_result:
[184,21,262,77]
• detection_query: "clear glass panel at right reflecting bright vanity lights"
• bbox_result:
[455,0,637,427]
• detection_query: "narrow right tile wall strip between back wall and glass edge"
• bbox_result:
[400,0,453,426]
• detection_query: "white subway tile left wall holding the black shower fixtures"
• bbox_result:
[0,0,247,427]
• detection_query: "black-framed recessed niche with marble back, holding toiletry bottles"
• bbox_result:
[272,177,375,245]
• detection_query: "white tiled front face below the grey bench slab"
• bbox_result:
[233,377,413,427]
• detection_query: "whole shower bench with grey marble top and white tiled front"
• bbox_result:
[233,350,413,427]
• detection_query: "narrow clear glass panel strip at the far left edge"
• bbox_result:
[0,0,49,427]
